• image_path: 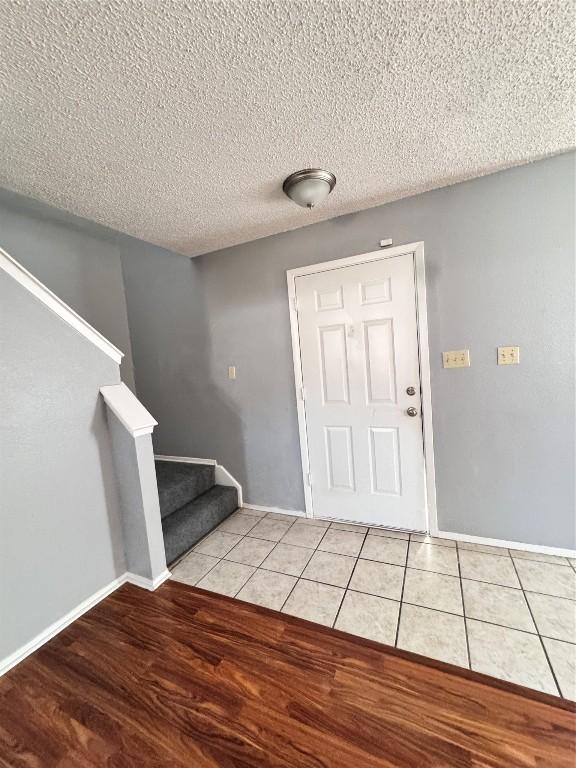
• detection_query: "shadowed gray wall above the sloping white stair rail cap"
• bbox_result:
[0,189,134,389]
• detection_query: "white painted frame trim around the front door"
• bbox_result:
[286,242,438,536]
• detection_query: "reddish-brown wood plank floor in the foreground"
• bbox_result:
[0,582,576,768]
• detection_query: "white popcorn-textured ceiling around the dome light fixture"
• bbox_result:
[0,0,575,255]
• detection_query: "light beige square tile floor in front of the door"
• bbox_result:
[172,509,576,699]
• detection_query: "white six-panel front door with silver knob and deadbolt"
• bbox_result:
[295,253,426,530]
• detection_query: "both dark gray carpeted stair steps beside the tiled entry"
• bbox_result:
[156,461,238,565]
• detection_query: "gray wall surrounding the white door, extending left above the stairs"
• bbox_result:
[122,153,576,547]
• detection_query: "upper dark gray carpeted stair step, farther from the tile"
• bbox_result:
[156,461,214,518]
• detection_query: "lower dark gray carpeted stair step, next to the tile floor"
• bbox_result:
[162,485,238,565]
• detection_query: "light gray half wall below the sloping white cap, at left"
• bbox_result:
[0,270,125,658]
